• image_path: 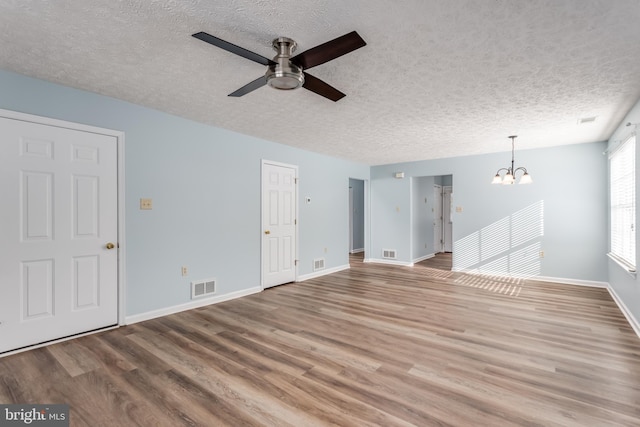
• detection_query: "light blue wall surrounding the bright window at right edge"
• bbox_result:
[607,97,640,323]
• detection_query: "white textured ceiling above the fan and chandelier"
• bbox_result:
[0,0,640,165]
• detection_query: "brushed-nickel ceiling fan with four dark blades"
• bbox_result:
[193,31,366,102]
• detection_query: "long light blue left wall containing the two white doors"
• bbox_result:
[0,71,369,315]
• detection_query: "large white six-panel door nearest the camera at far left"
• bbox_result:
[0,118,118,352]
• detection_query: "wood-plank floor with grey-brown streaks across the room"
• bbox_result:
[0,254,640,426]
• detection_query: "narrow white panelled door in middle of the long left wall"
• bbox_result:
[262,162,298,288]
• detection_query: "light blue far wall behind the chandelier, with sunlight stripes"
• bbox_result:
[371,142,608,282]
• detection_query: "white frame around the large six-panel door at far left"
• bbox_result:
[0,109,126,326]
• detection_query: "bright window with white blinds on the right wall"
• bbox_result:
[609,135,636,272]
